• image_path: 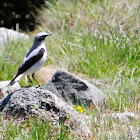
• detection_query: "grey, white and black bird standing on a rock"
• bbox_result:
[8,32,52,87]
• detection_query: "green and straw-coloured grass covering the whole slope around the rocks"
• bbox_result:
[0,0,140,139]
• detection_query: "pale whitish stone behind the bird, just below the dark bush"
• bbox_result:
[0,27,29,45]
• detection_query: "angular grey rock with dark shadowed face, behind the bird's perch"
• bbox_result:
[43,70,105,105]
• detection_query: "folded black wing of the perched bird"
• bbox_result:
[17,48,45,75]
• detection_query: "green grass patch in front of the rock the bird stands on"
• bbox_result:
[0,118,75,140]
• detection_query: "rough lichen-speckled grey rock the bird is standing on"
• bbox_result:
[0,87,91,137]
